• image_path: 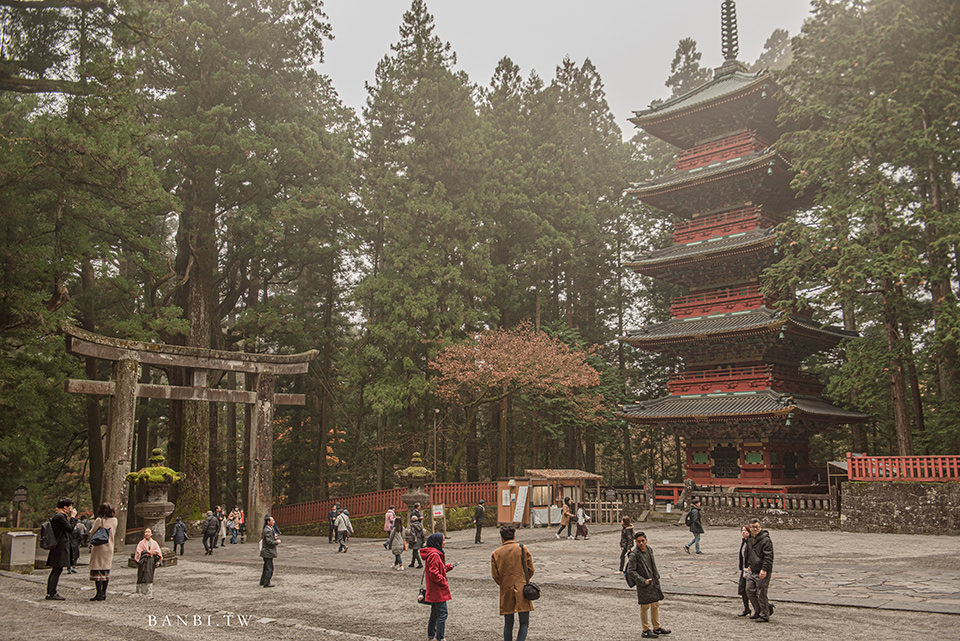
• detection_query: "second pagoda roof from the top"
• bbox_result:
[626,147,806,218]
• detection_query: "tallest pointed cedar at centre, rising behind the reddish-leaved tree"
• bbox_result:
[356,0,490,483]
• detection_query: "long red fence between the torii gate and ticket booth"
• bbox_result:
[271,482,497,527]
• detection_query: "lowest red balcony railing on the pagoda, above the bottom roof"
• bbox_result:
[667,365,823,396]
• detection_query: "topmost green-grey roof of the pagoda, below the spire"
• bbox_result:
[630,70,780,149]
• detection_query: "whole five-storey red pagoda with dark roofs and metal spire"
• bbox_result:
[619,0,866,486]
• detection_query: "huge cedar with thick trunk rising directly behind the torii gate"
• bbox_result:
[141,0,345,515]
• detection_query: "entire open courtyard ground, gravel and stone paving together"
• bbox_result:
[0,515,960,641]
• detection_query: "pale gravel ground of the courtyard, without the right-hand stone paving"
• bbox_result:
[0,528,960,641]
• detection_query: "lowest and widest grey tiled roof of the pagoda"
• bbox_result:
[615,389,868,423]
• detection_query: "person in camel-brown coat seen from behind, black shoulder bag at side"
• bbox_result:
[490,525,533,641]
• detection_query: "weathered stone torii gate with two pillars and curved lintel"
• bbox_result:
[63,326,319,552]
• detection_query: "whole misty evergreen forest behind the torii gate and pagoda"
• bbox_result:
[0,0,960,516]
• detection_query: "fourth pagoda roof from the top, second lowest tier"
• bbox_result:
[620,307,859,351]
